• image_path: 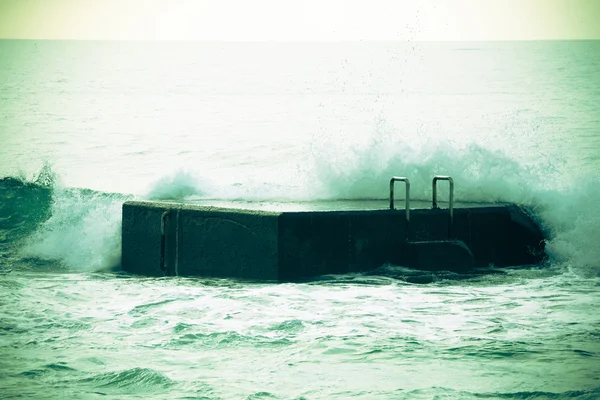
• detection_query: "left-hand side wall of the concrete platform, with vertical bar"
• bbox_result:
[122,202,279,280]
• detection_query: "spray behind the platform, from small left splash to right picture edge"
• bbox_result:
[138,138,600,275]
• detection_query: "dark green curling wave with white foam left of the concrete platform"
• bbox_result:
[0,166,133,271]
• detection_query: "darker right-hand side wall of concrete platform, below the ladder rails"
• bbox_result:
[279,206,543,280]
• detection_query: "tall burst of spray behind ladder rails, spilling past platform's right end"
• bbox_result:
[310,138,600,275]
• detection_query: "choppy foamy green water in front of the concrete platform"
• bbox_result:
[0,270,600,399]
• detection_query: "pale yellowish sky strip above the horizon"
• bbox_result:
[0,0,600,41]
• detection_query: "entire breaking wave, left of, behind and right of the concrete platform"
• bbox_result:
[0,140,600,275]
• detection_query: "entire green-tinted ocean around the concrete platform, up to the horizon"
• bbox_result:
[0,40,600,399]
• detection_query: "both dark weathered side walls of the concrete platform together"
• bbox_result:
[122,202,544,281]
